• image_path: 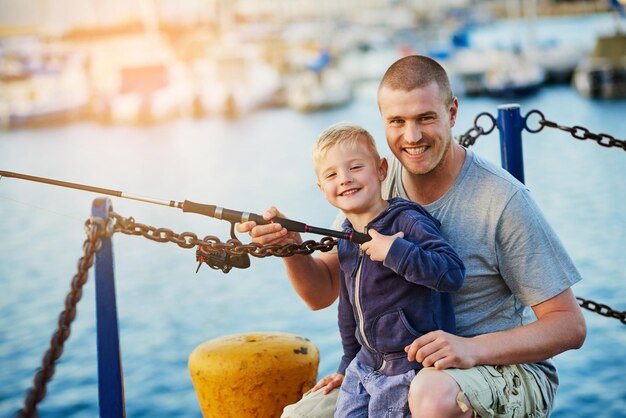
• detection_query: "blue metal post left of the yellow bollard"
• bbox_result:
[91,198,126,418]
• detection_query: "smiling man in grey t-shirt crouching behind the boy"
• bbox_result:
[239,56,586,417]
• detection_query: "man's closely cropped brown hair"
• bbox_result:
[378,55,453,106]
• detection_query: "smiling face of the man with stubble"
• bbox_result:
[378,82,458,174]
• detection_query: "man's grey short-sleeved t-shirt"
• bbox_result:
[383,150,581,404]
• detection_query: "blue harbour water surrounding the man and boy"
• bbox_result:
[0,13,626,418]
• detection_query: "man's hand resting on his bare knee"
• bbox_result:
[404,330,476,370]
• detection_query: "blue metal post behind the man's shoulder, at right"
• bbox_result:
[498,104,524,183]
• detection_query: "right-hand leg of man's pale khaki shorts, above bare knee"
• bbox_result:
[444,365,548,418]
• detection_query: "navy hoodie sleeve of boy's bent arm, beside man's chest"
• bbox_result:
[383,216,465,292]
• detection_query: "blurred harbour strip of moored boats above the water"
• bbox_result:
[0,0,626,125]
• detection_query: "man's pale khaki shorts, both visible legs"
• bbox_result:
[281,365,548,418]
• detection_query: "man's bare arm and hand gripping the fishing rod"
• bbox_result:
[237,207,340,310]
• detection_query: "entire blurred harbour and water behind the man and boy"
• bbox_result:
[0,0,626,418]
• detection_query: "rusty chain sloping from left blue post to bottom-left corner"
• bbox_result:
[17,218,110,418]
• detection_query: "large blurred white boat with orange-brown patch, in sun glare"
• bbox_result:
[88,34,194,124]
